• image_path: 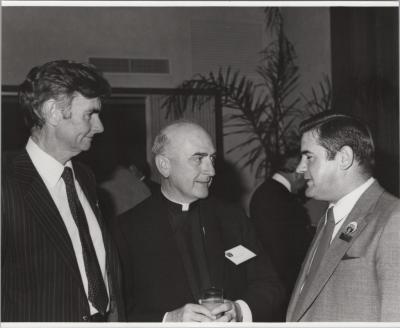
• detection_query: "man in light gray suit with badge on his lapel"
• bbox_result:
[286,113,400,321]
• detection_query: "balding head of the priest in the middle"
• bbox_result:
[152,121,215,203]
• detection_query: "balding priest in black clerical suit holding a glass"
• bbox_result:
[115,122,284,322]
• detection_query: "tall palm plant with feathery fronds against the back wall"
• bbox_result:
[163,8,331,178]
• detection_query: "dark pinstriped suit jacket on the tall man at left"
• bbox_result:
[1,150,124,321]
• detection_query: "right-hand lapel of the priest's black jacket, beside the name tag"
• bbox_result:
[200,200,225,288]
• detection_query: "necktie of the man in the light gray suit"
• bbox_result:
[301,206,335,294]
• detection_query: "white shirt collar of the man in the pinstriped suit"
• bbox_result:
[26,138,73,187]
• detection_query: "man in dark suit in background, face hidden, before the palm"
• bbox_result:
[250,151,313,320]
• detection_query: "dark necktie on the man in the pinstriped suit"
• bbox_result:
[61,167,108,314]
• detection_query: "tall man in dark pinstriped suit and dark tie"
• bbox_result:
[1,60,124,321]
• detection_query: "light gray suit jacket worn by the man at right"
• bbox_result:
[286,181,400,321]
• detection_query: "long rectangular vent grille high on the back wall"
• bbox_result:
[89,57,169,74]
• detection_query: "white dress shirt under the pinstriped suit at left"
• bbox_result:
[26,138,110,314]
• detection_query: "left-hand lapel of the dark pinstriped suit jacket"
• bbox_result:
[14,151,81,281]
